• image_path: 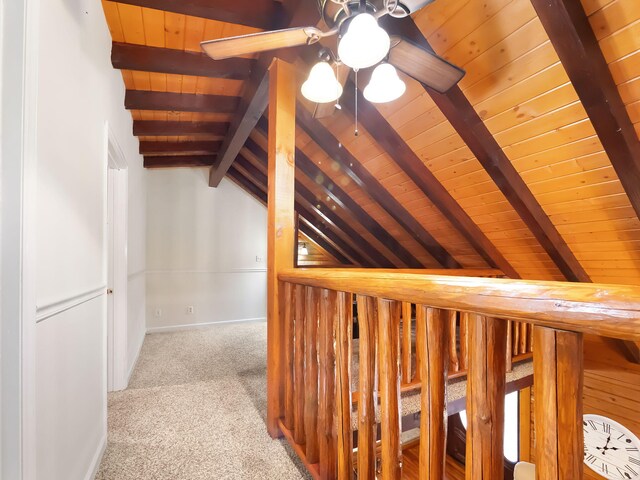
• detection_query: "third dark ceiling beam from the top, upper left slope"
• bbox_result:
[124,90,239,113]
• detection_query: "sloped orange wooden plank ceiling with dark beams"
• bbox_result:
[103,0,640,284]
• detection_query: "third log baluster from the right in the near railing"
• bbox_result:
[416,305,453,480]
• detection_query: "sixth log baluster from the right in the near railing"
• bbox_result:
[335,292,353,480]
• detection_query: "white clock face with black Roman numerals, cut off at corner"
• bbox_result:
[582,415,640,480]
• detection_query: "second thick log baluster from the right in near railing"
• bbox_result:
[465,314,507,480]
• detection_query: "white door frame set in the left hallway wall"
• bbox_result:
[105,123,129,391]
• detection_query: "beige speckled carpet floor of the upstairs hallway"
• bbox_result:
[96,322,311,480]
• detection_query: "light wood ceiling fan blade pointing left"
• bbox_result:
[200,27,335,60]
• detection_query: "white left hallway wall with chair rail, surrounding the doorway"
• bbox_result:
[35,0,145,480]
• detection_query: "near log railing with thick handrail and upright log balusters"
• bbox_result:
[278,269,640,480]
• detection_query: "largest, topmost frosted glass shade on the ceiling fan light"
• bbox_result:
[338,13,391,70]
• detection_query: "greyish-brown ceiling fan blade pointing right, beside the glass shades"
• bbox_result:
[389,37,466,93]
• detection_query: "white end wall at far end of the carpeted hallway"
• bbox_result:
[147,169,267,331]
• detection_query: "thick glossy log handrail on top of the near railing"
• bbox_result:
[278,268,640,340]
